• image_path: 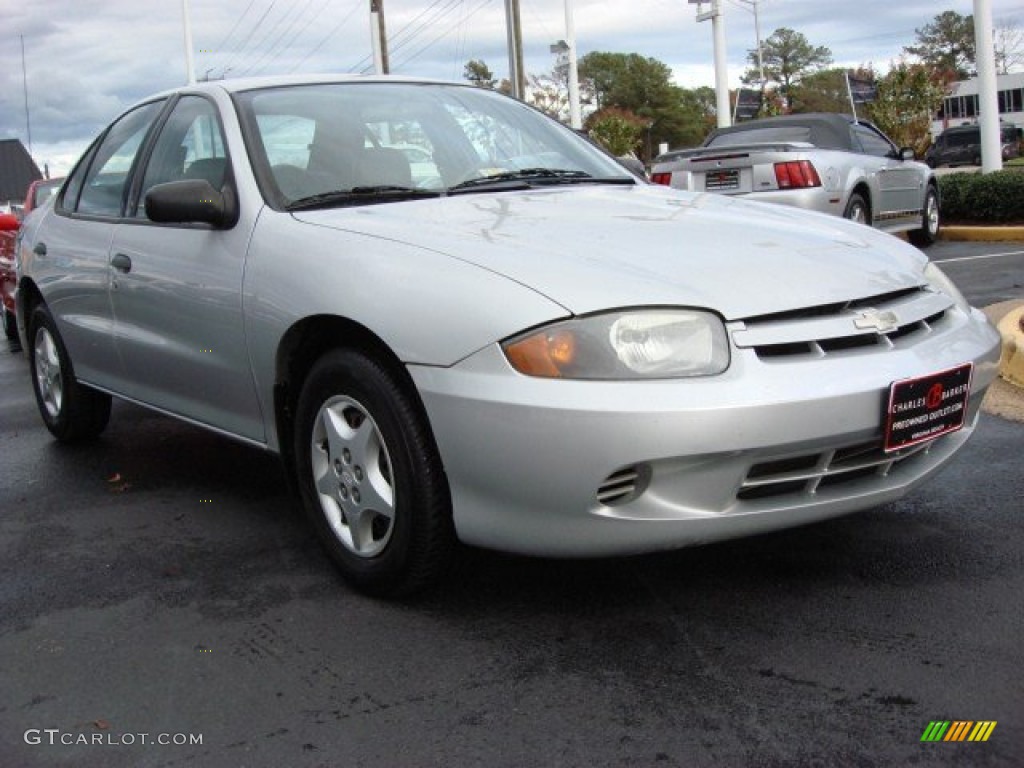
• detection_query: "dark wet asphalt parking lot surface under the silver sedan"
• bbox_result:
[0,237,1024,768]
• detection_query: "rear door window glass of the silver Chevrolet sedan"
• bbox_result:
[72,101,164,216]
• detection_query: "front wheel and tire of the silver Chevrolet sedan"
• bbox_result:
[294,349,455,597]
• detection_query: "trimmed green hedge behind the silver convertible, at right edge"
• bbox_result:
[939,170,1024,225]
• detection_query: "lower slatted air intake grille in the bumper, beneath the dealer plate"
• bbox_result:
[736,438,942,501]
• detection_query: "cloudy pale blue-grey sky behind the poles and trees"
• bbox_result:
[0,0,1024,175]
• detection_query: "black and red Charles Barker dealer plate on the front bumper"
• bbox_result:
[886,362,974,451]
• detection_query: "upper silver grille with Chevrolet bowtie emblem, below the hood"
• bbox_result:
[732,288,953,361]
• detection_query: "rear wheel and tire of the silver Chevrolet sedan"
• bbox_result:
[29,305,111,442]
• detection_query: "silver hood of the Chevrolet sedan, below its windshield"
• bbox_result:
[295,185,927,319]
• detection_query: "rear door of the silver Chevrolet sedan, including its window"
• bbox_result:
[34,100,166,389]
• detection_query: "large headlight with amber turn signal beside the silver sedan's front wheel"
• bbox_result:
[502,309,729,380]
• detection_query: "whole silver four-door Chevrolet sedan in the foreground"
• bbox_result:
[17,77,998,594]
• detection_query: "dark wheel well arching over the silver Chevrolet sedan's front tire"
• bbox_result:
[273,315,422,477]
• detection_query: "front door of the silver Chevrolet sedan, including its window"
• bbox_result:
[111,95,264,441]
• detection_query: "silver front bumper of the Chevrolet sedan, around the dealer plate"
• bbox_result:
[410,310,999,556]
